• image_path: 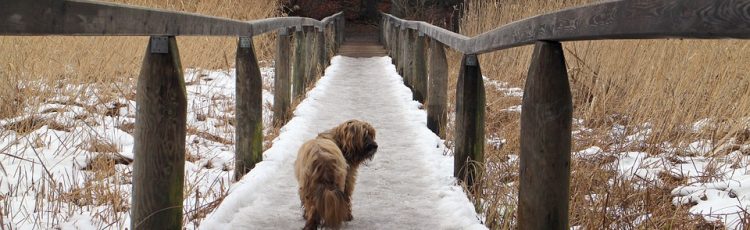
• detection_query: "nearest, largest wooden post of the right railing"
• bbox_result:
[518,41,573,229]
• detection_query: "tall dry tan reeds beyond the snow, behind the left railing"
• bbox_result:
[0,0,279,118]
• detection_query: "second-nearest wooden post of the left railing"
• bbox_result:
[234,37,263,181]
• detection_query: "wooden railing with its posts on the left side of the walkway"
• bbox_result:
[0,0,344,229]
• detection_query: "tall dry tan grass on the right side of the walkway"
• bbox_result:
[458,0,750,229]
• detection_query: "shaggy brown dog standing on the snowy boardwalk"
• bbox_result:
[294,120,378,229]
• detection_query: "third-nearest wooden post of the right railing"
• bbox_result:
[427,40,448,138]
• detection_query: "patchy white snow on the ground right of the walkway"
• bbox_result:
[484,77,750,229]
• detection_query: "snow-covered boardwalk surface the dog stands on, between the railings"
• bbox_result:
[200,56,485,229]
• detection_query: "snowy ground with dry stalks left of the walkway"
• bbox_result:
[0,68,273,229]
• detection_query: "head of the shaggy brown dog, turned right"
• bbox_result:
[332,120,378,164]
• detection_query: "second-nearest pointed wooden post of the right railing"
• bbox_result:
[453,54,485,190]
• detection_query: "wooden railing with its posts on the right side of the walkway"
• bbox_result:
[381,0,750,229]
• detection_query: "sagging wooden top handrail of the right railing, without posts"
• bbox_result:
[383,0,750,54]
